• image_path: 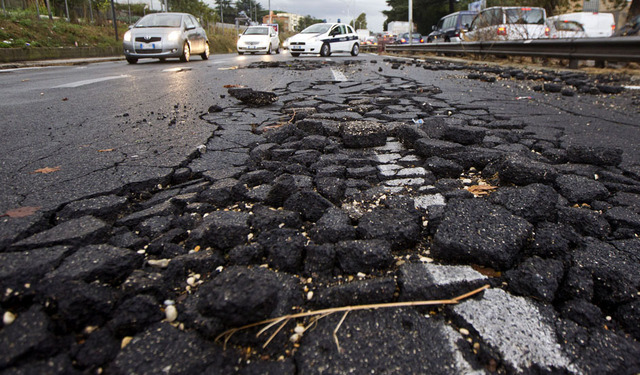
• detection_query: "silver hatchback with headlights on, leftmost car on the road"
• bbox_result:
[123,13,209,64]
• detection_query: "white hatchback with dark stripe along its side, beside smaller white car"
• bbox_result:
[289,23,360,57]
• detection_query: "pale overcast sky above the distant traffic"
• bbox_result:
[250,0,390,32]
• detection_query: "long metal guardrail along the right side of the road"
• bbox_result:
[363,36,640,62]
